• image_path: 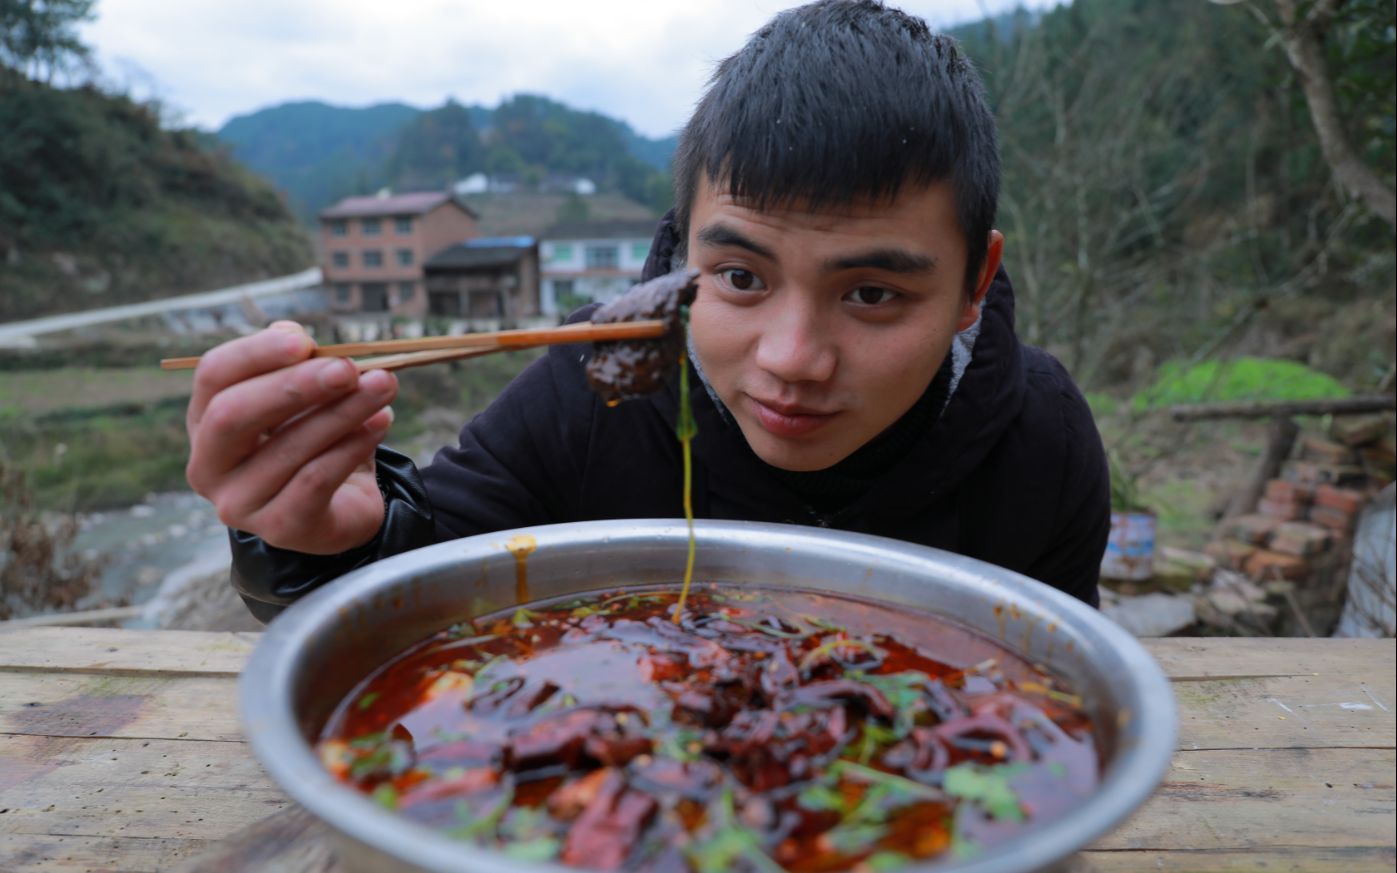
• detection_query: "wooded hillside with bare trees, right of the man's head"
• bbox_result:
[958,0,1397,387]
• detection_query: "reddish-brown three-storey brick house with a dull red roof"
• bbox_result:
[320,191,479,318]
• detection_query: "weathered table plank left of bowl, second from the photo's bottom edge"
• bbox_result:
[0,736,289,839]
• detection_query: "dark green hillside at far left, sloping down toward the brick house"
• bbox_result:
[0,0,313,321]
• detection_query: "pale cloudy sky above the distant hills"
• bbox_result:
[82,0,1051,137]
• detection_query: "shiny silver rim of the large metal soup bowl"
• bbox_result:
[239,518,1178,873]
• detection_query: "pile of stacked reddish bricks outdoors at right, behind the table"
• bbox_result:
[1206,416,1397,582]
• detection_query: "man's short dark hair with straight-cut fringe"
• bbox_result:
[673,0,999,289]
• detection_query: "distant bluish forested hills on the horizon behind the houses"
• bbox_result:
[218,94,673,219]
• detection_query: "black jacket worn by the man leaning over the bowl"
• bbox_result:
[231,219,1109,620]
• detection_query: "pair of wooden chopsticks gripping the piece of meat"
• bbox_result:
[161,318,669,372]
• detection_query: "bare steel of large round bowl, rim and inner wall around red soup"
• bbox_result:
[240,520,1178,873]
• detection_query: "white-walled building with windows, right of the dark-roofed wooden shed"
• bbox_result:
[539,218,659,316]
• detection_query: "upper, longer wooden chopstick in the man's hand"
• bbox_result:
[161,318,669,370]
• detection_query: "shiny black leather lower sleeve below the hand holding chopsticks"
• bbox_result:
[228,446,436,622]
